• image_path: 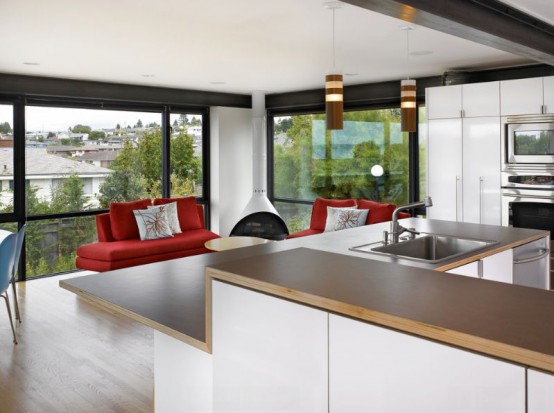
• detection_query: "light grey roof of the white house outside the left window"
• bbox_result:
[0,148,112,176]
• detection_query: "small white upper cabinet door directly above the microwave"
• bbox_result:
[500,77,544,116]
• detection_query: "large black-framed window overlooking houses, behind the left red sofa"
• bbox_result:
[10,104,204,278]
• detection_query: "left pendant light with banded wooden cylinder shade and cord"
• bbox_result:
[323,1,343,130]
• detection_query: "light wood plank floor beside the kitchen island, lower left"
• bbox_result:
[0,274,154,413]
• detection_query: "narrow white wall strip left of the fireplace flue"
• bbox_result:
[210,107,252,237]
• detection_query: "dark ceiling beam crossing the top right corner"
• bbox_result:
[343,0,554,66]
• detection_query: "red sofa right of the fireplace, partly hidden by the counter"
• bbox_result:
[287,198,411,239]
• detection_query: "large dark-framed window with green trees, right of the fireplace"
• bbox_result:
[273,108,410,227]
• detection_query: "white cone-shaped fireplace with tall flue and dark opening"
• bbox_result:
[231,92,289,240]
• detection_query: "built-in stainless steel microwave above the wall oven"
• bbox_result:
[505,117,554,166]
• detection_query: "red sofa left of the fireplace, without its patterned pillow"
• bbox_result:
[76,197,220,272]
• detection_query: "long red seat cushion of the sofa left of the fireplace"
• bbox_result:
[77,229,219,261]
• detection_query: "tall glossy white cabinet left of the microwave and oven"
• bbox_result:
[427,82,501,225]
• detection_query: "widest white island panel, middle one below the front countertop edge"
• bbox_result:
[330,314,525,413]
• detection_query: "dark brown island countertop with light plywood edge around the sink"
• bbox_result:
[60,218,554,372]
